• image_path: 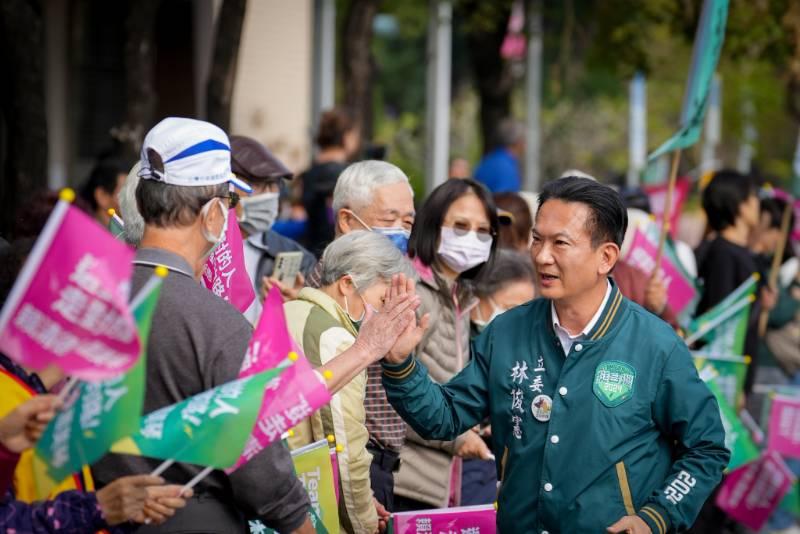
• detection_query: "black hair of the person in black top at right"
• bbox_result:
[703,170,757,232]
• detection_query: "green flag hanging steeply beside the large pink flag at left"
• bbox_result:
[36,271,166,481]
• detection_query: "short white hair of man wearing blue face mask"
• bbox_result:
[332,159,414,213]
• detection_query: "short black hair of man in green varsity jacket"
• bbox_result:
[537,176,628,248]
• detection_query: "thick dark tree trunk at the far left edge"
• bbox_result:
[0,0,47,237]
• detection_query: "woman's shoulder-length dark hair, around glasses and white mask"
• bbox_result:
[408,179,500,279]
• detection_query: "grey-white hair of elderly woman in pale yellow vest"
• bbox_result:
[320,230,416,291]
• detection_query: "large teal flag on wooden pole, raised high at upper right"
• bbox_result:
[648,0,728,161]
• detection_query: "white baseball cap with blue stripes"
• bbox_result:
[139,117,252,193]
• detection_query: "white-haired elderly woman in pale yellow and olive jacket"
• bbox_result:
[285,231,414,533]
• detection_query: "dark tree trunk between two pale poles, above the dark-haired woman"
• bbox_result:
[457,2,514,154]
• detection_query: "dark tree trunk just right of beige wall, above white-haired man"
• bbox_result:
[342,0,380,145]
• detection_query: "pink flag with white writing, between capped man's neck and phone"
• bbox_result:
[203,208,256,313]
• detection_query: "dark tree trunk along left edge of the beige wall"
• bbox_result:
[206,0,247,132]
